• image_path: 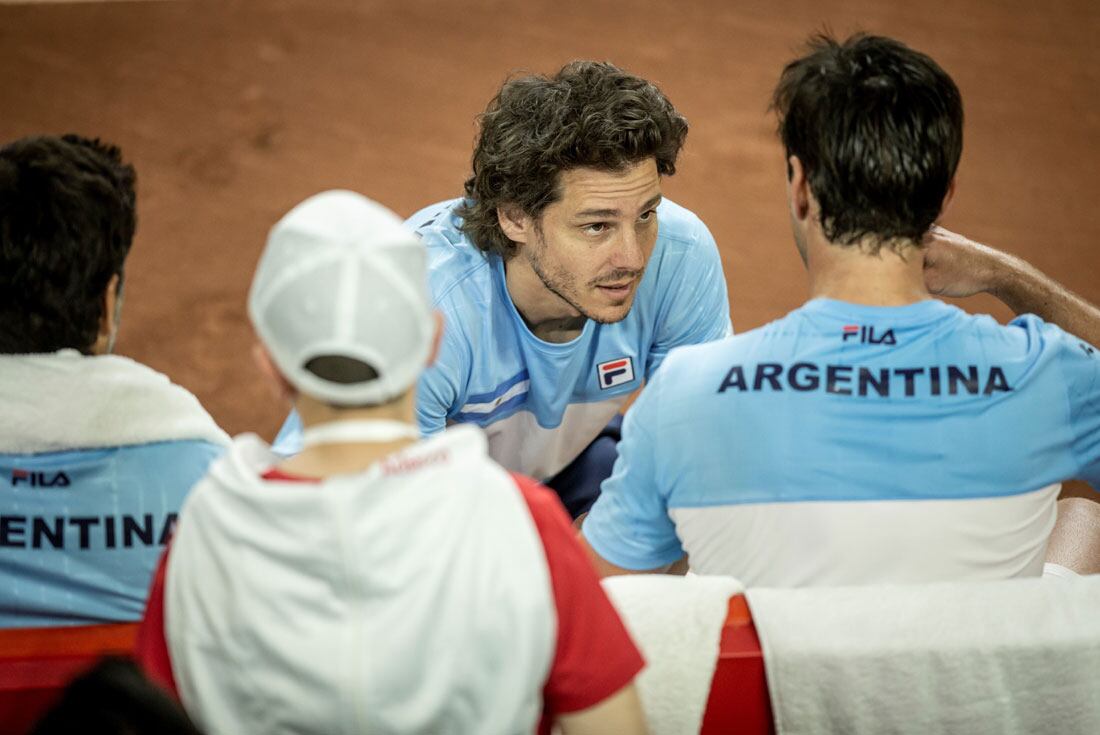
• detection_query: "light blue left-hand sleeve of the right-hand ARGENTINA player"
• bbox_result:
[582,369,684,571]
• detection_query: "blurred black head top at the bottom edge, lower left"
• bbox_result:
[31,658,200,735]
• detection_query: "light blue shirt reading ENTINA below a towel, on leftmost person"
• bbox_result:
[0,440,224,628]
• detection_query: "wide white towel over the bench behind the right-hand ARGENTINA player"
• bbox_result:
[747,577,1100,735]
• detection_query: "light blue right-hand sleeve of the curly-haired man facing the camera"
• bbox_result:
[646,215,734,380]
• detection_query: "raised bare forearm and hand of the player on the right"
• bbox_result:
[924,227,1100,344]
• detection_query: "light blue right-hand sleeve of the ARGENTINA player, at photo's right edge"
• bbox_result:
[1036,319,1100,490]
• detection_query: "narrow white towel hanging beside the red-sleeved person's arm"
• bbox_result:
[604,574,744,735]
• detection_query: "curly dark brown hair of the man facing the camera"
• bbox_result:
[458,62,688,257]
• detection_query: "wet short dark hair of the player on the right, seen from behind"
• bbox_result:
[772,33,963,244]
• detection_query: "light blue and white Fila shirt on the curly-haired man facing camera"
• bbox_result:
[275,199,732,480]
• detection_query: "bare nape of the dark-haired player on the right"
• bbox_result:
[806,230,931,306]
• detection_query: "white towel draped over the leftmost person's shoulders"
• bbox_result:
[0,350,230,454]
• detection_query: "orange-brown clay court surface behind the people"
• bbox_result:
[0,0,1100,499]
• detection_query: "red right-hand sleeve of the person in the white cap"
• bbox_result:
[513,475,645,716]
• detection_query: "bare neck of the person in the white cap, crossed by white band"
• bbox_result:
[278,388,417,478]
